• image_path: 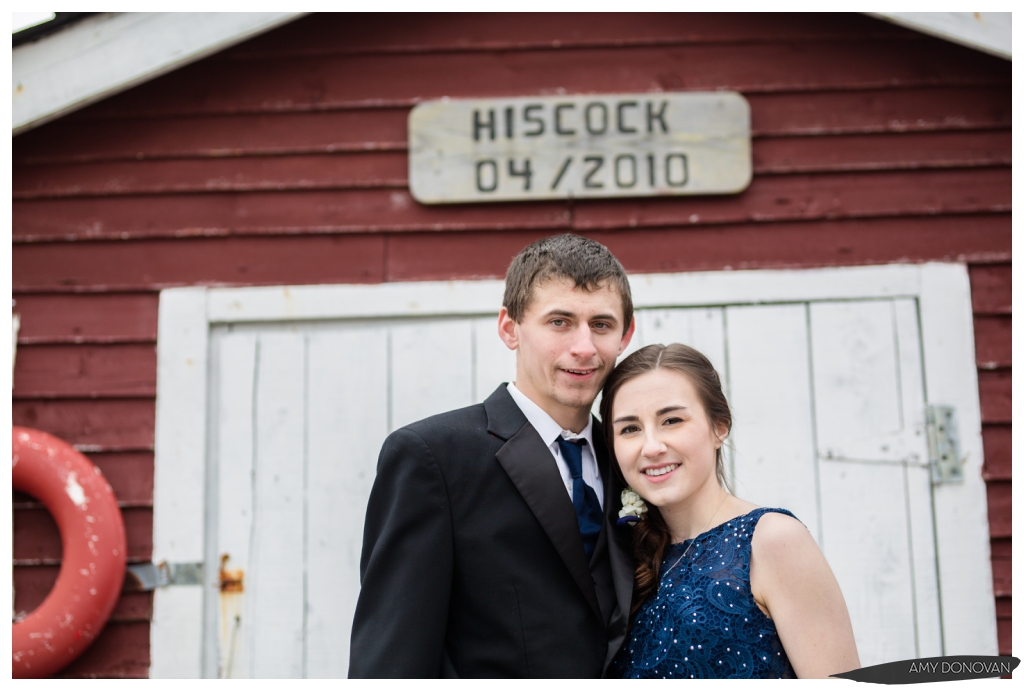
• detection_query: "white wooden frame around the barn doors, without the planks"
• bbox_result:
[150,263,997,678]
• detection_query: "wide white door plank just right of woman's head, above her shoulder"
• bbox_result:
[725,304,821,545]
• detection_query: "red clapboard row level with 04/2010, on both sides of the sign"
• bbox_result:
[14,130,1010,200]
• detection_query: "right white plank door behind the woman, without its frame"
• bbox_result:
[639,299,942,666]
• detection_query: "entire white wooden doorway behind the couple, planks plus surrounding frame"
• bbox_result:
[152,267,995,678]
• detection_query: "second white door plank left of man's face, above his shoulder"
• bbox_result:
[391,319,473,429]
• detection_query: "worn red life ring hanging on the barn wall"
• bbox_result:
[11,427,127,679]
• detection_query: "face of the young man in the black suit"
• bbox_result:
[498,276,633,431]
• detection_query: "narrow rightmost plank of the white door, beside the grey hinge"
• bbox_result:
[893,299,942,657]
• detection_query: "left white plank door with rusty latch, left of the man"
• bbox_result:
[207,317,515,678]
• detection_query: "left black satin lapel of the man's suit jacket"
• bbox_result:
[483,384,601,616]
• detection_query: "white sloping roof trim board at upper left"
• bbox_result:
[11,12,303,134]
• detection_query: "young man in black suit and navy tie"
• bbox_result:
[349,235,634,678]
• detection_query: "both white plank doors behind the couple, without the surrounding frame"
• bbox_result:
[212,299,942,678]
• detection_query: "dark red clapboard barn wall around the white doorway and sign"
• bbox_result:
[12,14,1012,677]
